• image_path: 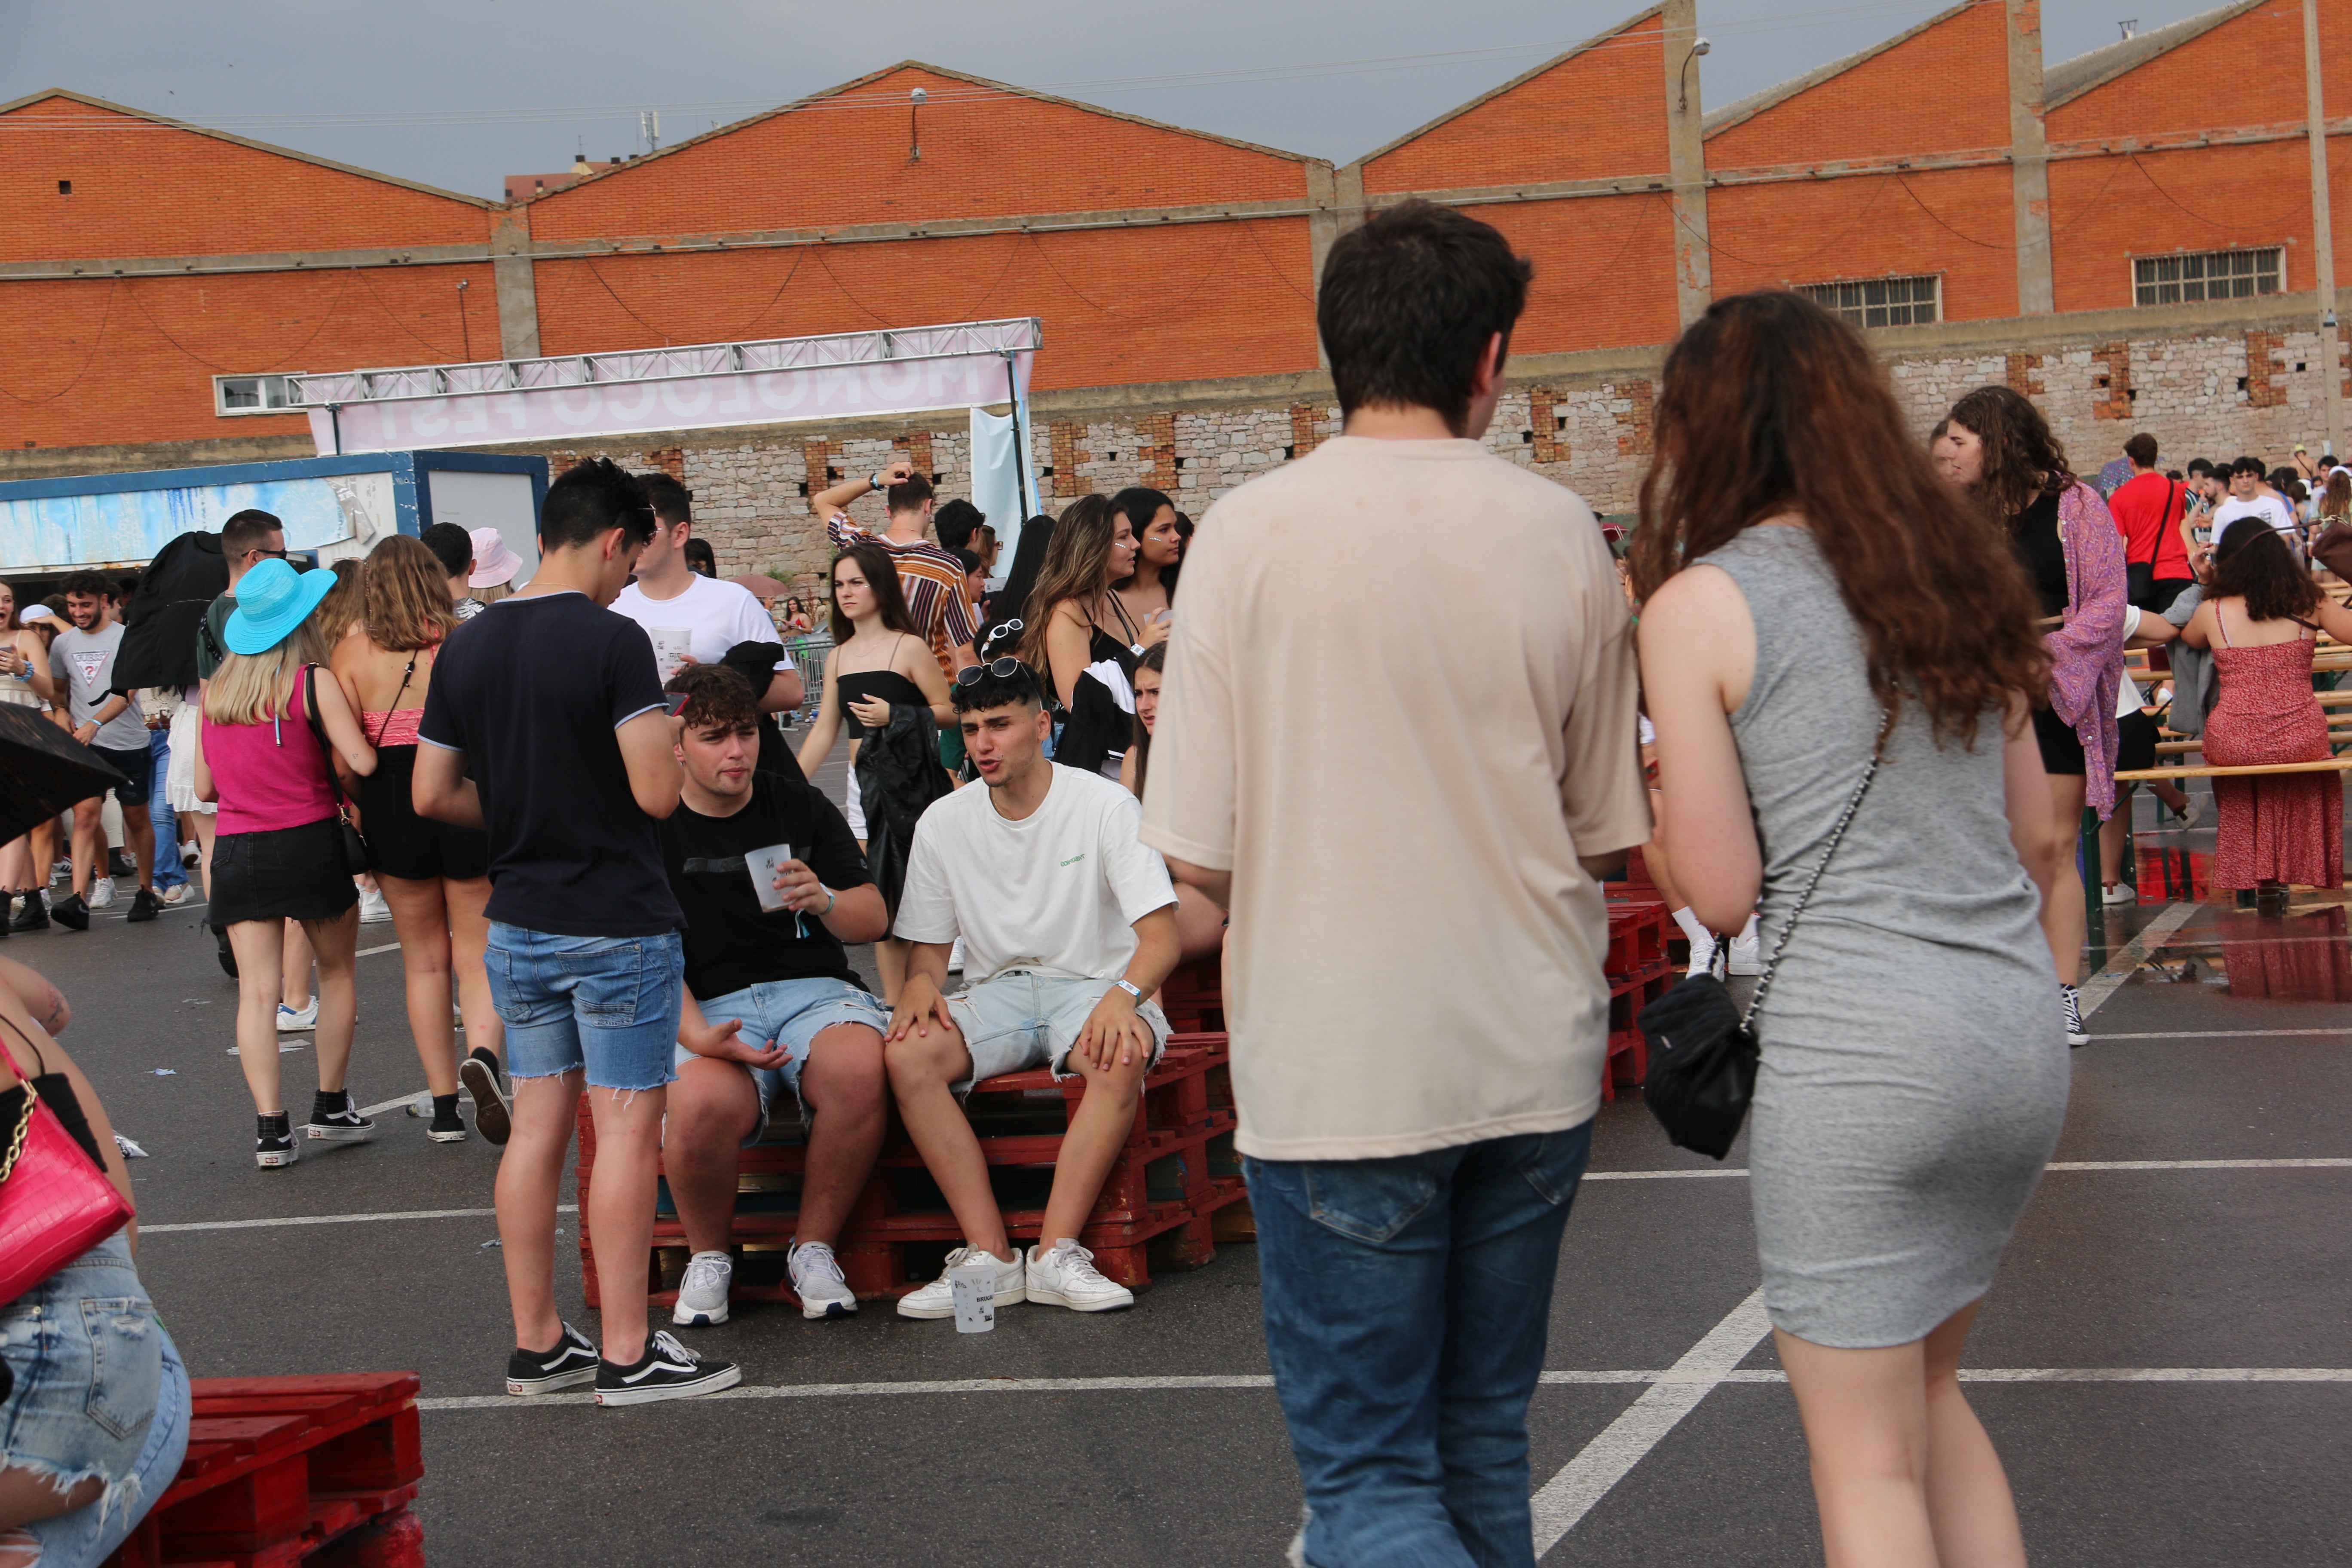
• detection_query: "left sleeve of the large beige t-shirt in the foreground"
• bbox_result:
[1143,517,1237,872]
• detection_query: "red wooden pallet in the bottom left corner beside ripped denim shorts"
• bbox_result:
[106,1373,426,1568]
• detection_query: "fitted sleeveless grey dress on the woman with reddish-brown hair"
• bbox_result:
[1705,527,2067,1349]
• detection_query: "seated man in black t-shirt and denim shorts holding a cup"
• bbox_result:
[661,665,889,1326]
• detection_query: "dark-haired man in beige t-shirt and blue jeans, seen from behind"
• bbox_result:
[1143,202,1649,1568]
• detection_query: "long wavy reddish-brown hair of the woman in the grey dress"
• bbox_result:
[1628,289,2049,745]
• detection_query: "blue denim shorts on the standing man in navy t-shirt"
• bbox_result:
[482,919,687,1091]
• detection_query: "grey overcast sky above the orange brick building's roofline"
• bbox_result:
[0,0,2208,197]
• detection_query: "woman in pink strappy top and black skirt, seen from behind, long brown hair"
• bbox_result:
[334,527,508,1142]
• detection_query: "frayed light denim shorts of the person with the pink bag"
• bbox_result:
[0,1232,188,1568]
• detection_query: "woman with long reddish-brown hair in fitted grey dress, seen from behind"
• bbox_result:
[1632,291,2067,1568]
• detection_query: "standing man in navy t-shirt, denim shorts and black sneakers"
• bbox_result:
[414,459,743,1406]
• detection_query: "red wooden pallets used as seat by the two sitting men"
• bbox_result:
[579,1034,1244,1305]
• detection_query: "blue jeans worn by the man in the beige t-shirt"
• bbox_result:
[1244,1121,1592,1568]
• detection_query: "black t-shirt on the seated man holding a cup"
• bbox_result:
[661,773,873,1001]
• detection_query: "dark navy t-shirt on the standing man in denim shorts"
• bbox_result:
[416,592,680,936]
